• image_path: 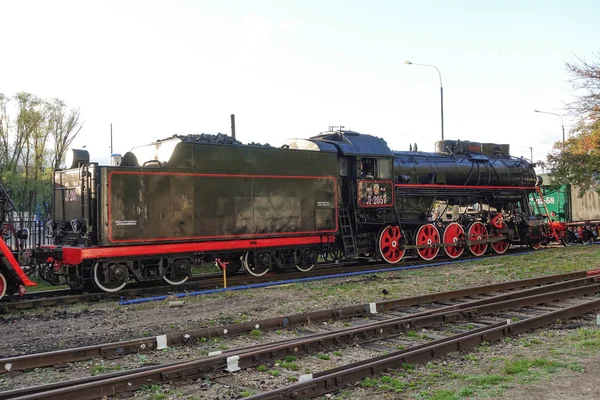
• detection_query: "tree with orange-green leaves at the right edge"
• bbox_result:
[548,53,600,196]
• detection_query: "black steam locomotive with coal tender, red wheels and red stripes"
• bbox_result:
[0,130,543,292]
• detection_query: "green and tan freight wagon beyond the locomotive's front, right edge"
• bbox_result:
[529,175,600,246]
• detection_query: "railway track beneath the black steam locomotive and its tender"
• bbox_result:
[0,248,540,314]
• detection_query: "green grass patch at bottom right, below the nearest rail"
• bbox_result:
[352,327,600,400]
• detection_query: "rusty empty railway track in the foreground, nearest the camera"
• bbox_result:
[0,271,600,399]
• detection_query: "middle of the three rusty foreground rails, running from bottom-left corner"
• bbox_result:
[0,276,600,400]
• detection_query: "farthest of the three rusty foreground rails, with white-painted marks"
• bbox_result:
[0,271,589,373]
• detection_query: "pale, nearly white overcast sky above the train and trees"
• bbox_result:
[0,0,600,164]
